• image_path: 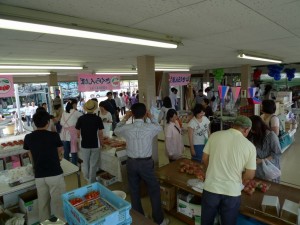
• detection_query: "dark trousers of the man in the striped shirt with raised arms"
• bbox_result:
[127,159,164,224]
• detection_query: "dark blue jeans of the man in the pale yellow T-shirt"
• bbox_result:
[201,190,241,225]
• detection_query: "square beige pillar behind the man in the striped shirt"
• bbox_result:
[137,55,158,167]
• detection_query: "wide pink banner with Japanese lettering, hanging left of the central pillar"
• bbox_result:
[78,74,120,92]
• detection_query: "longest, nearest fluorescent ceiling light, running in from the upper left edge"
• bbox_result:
[0,19,177,48]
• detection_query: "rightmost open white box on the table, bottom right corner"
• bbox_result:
[280,199,300,224]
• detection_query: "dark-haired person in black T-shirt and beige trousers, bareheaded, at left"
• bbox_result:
[23,111,66,221]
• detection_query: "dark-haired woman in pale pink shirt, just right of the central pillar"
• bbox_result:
[165,109,184,162]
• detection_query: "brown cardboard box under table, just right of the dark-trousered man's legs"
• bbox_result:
[160,184,176,211]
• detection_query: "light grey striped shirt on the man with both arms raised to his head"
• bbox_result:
[114,119,162,158]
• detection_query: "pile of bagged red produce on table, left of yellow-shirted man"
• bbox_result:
[179,159,205,181]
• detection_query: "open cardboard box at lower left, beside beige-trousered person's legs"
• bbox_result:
[19,189,39,225]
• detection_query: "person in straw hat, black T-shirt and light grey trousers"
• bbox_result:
[75,100,104,183]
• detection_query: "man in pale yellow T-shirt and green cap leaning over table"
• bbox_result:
[201,116,256,225]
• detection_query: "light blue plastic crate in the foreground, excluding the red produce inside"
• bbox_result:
[62,183,132,225]
